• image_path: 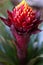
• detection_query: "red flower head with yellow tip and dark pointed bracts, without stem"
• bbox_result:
[1,2,42,34]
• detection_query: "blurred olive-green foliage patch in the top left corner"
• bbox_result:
[0,0,13,16]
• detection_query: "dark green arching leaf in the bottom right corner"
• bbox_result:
[27,54,43,65]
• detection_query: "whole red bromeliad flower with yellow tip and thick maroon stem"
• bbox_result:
[0,0,42,63]
